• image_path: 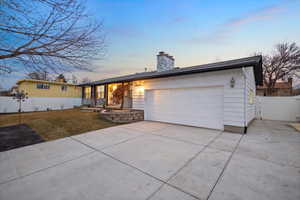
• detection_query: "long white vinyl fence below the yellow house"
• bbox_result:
[0,97,81,113]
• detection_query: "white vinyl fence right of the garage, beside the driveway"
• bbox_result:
[256,96,300,122]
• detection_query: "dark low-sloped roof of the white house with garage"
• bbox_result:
[80,56,263,86]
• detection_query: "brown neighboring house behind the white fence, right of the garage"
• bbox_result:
[256,78,293,96]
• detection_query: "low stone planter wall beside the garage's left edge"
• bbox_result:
[100,110,144,123]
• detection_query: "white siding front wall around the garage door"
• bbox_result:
[133,69,250,127]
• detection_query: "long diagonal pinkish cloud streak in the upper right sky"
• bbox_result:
[188,3,286,44]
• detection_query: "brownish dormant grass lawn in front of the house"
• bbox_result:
[0,109,117,140]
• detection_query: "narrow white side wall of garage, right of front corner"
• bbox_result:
[245,67,256,125]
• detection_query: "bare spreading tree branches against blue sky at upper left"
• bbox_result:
[0,0,105,73]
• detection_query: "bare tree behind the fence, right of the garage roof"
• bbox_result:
[255,43,300,95]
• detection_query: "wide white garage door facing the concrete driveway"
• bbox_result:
[145,87,223,129]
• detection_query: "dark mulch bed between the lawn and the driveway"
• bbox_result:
[0,124,44,152]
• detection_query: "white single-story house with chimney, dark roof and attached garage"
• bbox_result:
[81,52,262,132]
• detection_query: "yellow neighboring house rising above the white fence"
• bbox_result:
[17,79,82,98]
